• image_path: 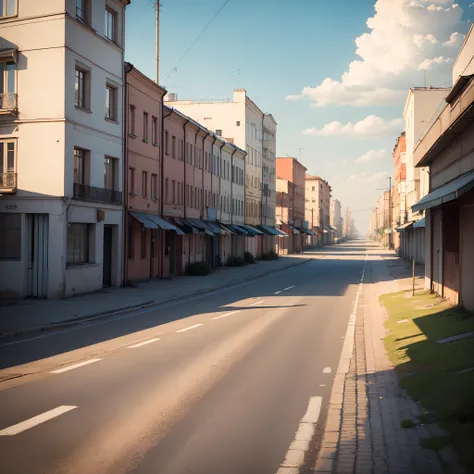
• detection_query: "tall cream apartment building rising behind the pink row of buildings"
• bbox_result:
[165,89,276,256]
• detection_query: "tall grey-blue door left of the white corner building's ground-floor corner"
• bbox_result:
[26,214,49,298]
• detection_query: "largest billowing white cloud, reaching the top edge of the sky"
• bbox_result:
[287,0,468,107]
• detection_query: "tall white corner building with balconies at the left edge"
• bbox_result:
[0,0,130,298]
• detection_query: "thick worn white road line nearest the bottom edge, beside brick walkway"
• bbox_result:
[277,397,323,474]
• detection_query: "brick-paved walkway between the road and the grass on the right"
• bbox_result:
[315,250,463,474]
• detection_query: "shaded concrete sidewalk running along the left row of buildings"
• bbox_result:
[0,254,314,338]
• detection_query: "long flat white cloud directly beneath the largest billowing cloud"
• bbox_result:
[303,115,404,138]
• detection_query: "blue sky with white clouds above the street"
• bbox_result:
[125,0,474,234]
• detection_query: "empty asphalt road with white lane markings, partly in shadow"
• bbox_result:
[0,241,366,474]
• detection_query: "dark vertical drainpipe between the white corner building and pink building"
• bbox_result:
[122,62,133,284]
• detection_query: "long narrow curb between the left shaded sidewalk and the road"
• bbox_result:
[0,258,314,343]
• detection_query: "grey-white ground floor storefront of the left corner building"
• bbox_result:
[0,198,123,299]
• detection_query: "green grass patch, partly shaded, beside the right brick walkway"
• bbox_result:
[380,291,474,472]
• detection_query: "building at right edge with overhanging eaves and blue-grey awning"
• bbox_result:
[412,25,474,311]
